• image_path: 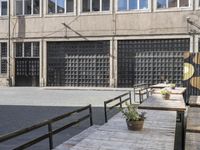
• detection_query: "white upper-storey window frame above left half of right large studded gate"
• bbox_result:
[115,0,151,13]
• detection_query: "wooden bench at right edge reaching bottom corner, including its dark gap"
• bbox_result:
[185,107,200,150]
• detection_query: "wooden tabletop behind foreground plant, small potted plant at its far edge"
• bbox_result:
[138,94,186,111]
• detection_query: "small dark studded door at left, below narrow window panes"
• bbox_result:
[15,58,39,86]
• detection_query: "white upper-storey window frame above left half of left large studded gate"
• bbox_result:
[45,0,77,16]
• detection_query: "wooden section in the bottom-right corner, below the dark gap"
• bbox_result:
[185,132,200,150]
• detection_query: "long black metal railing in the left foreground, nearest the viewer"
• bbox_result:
[0,105,93,150]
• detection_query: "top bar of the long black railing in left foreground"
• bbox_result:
[0,105,91,142]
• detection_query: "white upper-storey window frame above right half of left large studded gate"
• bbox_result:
[79,0,112,15]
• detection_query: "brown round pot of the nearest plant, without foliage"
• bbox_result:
[126,120,144,131]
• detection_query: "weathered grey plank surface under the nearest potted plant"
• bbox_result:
[71,110,176,150]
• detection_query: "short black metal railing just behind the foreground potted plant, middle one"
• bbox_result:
[104,91,132,122]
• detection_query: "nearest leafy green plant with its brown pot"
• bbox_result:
[121,103,145,131]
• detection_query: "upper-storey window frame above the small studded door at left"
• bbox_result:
[13,0,42,16]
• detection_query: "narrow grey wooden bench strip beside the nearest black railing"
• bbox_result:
[54,125,100,150]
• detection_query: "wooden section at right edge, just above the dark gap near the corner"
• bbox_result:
[186,107,200,133]
